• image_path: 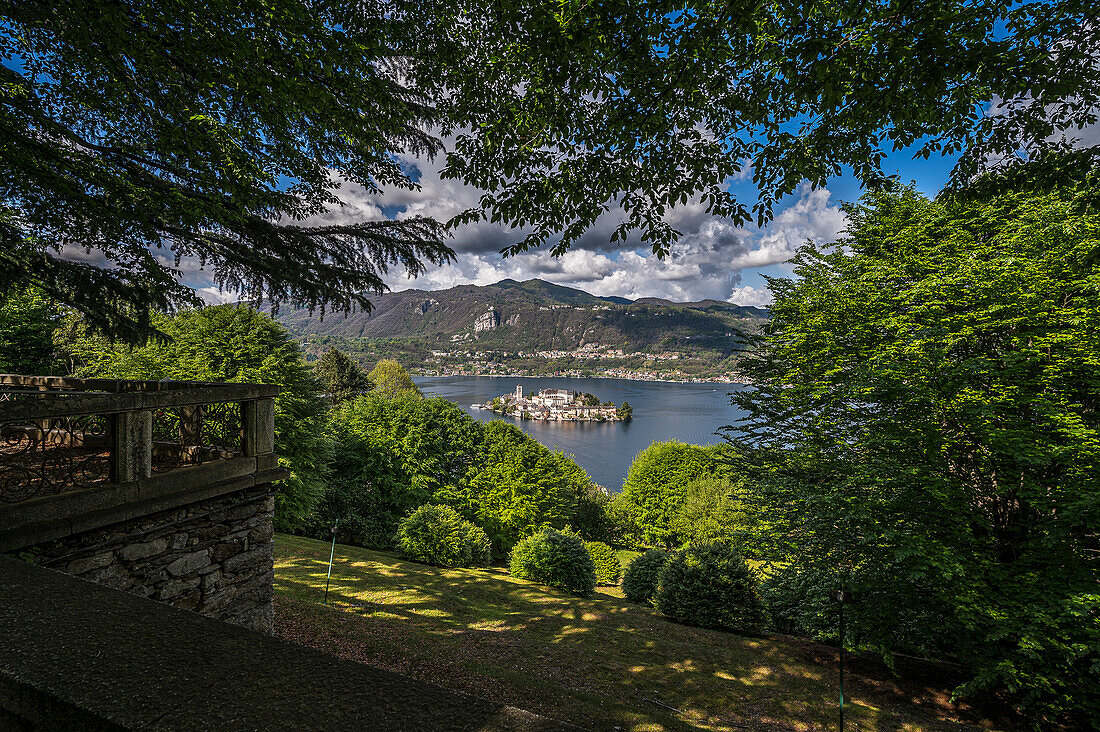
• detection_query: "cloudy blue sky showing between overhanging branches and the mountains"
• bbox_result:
[188,145,954,306]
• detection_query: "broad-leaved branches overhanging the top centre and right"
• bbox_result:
[409,0,1100,255]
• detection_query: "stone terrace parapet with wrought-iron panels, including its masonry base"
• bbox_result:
[0,374,287,633]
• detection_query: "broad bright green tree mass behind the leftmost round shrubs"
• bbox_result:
[319,392,598,554]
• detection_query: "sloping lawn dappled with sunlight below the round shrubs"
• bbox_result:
[275,535,998,732]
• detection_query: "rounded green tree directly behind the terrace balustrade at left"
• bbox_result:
[66,305,330,531]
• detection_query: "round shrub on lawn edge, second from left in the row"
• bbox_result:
[509,529,596,596]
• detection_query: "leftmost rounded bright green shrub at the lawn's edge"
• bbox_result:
[397,504,488,567]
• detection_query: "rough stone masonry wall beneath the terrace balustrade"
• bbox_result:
[18,485,275,634]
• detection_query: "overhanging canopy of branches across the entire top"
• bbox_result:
[0,0,1100,338]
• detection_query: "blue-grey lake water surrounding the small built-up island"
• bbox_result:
[416,376,748,492]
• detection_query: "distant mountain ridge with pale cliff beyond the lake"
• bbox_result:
[271,280,768,351]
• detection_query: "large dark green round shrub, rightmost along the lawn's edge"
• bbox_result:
[653,544,765,634]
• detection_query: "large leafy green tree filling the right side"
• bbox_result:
[733,181,1100,726]
